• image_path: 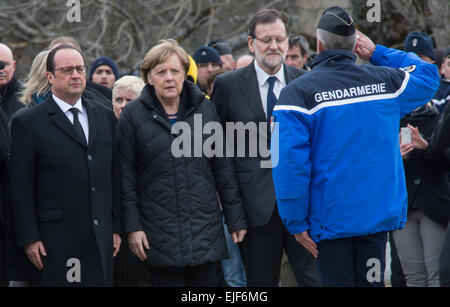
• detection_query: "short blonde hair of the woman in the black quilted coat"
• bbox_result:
[141,39,190,84]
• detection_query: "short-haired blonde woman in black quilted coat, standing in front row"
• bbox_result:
[117,40,247,287]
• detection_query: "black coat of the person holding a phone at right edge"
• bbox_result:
[401,105,450,226]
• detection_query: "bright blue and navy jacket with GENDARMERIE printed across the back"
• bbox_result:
[271,45,439,242]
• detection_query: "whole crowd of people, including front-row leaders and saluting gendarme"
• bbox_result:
[0,6,450,287]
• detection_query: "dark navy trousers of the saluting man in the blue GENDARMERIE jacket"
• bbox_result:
[317,232,387,287]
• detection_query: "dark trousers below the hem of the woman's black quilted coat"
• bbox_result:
[151,262,220,287]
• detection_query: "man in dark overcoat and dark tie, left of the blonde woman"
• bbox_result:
[11,45,120,286]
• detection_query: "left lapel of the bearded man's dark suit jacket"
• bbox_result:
[239,62,266,122]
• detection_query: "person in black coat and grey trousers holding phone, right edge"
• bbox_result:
[398,103,450,287]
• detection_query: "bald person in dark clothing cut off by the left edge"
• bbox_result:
[0,43,24,123]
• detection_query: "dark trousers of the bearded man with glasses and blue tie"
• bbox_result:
[240,207,320,287]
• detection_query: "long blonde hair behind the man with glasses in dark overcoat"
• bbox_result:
[19,50,50,106]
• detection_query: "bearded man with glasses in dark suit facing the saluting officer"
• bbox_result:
[211,9,318,287]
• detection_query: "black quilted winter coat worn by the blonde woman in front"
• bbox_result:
[117,81,247,267]
